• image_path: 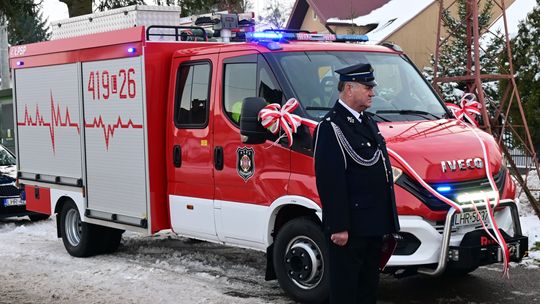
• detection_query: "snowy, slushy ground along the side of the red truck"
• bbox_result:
[0,219,290,304]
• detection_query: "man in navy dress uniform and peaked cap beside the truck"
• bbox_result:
[314,63,399,304]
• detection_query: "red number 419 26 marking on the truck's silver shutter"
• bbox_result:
[87,68,137,100]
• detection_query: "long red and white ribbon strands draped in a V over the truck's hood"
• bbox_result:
[387,120,510,277]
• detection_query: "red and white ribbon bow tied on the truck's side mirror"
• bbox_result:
[259,98,317,147]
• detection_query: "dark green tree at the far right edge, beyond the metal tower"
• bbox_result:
[508,0,540,153]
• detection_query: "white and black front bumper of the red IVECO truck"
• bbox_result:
[387,200,528,276]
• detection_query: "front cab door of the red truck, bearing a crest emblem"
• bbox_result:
[213,51,290,248]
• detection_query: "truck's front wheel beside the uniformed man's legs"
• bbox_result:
[273,218,329,303]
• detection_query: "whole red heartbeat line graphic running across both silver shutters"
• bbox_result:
[17,90,143,154]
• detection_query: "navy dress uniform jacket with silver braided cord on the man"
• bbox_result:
[314,102,399,236]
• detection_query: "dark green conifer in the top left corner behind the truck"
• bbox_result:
[0,0,50,45]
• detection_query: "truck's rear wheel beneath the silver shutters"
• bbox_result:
[60,202,100,257]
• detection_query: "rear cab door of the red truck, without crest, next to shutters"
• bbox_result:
[166,55,217,240]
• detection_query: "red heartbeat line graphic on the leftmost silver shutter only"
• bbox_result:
[17,90,80,154]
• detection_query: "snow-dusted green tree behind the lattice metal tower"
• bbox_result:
[424,0,504,103]
